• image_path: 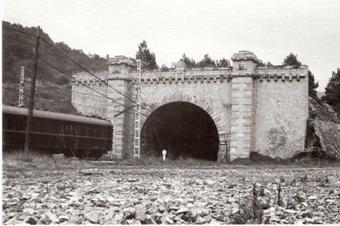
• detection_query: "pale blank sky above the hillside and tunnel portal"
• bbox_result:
[3,0,340,91]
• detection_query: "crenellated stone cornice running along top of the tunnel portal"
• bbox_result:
[72,66,308,85]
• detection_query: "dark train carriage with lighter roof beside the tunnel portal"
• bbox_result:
[3,105,112,158]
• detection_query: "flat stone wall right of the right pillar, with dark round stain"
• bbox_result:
[253,68,308,159]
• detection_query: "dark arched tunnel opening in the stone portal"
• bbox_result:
[141,102,219,161]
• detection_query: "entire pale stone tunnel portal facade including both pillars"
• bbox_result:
[72,51,308,162]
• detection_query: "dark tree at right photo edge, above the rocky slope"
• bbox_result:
[322,68,340,116]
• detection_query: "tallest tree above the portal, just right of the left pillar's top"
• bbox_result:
[136,40,158,70]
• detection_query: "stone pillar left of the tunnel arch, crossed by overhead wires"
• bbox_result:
[106,56,136,158]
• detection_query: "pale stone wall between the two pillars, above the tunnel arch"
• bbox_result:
[137,70,231,159]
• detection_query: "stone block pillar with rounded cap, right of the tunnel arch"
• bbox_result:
[229,51,260,161]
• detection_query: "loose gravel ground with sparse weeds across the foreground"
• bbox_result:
[2,165,340,224]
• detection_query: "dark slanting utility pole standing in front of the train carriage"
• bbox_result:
[25,26,40,153]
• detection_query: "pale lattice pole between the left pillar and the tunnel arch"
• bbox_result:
[133,59,142,159]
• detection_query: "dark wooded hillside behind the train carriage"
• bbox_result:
[2,21,107,113]
